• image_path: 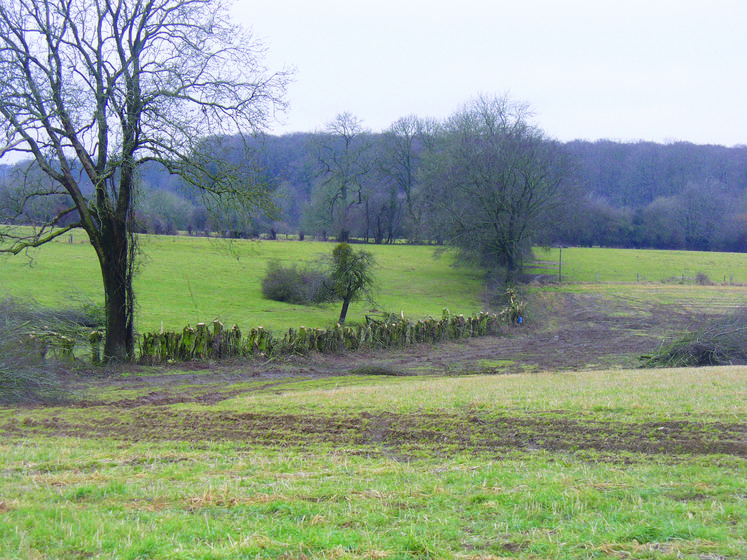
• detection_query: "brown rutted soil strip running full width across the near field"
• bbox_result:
[5,406,747,458]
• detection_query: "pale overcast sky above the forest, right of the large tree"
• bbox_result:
[234,0,747,146]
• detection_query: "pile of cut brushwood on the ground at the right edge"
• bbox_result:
[641,307,747,367]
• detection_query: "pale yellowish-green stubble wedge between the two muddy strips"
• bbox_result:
[209,368,747,419]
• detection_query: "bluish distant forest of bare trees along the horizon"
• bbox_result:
[0,134,747,252]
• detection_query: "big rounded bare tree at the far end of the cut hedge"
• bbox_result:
[426,98,568,283]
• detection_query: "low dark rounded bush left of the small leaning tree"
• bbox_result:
[262,261,332,305]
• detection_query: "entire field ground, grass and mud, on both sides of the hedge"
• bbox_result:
[0,237,747,560]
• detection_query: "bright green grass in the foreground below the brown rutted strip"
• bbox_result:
[0,441,747,560]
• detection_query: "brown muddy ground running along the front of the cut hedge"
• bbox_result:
[87,293,710,390]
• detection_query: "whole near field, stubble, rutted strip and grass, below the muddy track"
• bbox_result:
[0,367,747,560]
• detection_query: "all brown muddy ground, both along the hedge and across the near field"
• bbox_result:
[7,293,747,461]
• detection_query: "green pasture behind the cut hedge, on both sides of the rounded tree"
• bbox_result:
[0,234,747,331]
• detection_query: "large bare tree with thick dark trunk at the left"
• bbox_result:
[0,0,289,360]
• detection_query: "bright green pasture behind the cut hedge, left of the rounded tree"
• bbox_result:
[0,234,483,331]
